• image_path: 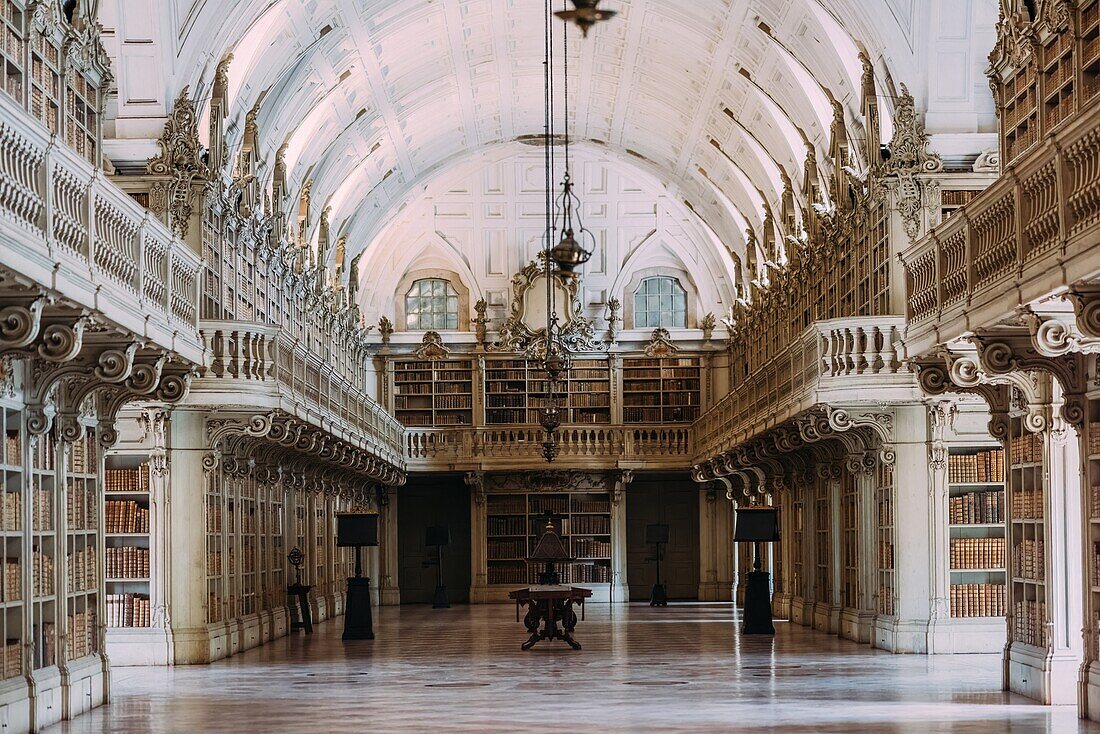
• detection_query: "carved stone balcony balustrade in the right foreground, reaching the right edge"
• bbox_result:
[901,103,1100,355]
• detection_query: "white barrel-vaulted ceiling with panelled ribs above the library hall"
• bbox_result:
[159,0,950,267]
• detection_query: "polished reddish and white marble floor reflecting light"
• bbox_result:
[47,604,1100,734]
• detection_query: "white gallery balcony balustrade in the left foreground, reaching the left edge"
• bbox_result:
[0,95,204,364]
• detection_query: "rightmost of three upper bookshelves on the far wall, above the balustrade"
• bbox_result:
[623,357,702,424]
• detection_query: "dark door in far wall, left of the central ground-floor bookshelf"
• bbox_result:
[397,476,470,604]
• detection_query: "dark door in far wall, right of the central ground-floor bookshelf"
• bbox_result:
[626,478,699,602]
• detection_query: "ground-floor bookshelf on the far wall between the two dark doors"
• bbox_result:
[485,492,613,585]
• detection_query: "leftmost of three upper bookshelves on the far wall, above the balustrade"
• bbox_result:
[394,360,474,427]
